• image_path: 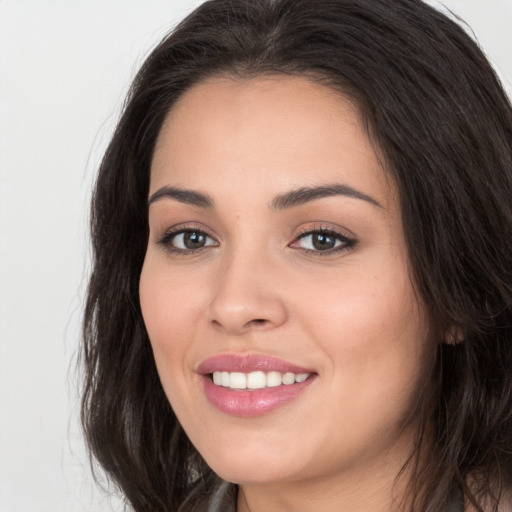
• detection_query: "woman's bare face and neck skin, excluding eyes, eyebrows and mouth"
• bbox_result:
[140,76,429,512]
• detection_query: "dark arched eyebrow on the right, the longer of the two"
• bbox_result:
[270,183,384,210]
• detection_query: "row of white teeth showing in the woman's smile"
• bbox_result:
[213,372,310,389]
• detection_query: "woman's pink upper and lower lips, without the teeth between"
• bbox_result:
[197,354,316,417]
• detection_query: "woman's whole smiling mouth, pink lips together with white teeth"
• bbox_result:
[197,354,317,417]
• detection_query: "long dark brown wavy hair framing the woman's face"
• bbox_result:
[82,0,512,512]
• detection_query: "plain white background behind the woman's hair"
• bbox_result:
[0,0,512,512]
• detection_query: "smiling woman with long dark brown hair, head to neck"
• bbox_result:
[82,0,512,512]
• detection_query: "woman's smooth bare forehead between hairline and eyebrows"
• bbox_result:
[151,76,394,210]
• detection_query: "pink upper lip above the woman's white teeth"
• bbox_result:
[197,354,314,375]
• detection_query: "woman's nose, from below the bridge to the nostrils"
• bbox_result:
[209,249,287,336]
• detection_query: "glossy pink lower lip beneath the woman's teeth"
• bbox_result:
[203,375,315,417]
